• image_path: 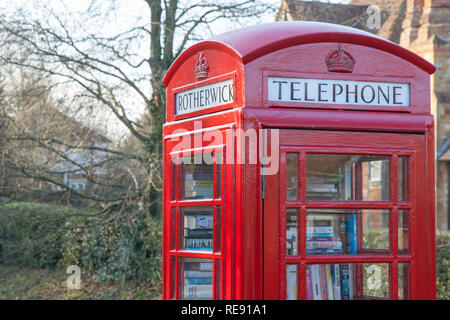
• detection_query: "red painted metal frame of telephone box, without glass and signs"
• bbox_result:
[163,22,436,299]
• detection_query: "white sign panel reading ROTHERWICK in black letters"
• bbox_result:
[175,79,234,115]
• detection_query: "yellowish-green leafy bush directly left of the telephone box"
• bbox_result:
[62,210,162,283]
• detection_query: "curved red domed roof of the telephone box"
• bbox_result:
[163,21,436,86]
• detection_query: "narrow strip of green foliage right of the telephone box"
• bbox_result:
[436,232,450,300]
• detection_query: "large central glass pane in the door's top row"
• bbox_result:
[306,154,389,201]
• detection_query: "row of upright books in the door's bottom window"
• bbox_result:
[306,263,353,300]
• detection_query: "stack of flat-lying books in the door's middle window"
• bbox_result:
[306,215,344,255]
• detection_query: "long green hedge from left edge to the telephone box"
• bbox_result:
[0,202,162,282]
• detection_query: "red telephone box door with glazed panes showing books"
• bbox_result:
[263,129,433,300]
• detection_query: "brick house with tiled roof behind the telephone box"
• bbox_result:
[276,0,450,230]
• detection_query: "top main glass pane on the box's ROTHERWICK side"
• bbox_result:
[182,155,213,200]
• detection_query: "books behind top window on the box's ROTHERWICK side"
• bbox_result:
[184,165,213,199]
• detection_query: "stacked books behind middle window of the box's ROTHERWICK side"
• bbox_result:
[184,212,213,250]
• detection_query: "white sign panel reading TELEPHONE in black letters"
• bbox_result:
[268,77,410,107]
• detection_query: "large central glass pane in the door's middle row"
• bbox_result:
[306,209,389,255]
